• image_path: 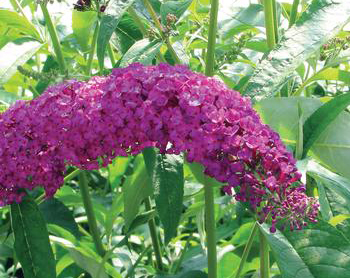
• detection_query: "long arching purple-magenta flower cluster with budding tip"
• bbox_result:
[0,63,318,231]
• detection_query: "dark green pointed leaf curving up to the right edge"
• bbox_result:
[303,93,350,157]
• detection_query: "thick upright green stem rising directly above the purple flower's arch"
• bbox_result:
[205,0,219,76]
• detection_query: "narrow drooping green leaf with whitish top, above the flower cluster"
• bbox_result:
[97,0,135,68]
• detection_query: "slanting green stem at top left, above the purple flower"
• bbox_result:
[40,1,66,75]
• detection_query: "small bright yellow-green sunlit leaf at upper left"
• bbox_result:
[72,10,97,52]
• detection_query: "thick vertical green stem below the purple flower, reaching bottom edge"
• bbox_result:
[204,183,217,278]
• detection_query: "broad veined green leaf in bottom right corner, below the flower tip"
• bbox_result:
[260,221,350,278]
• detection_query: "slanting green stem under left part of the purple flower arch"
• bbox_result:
[79,171,106,257]
